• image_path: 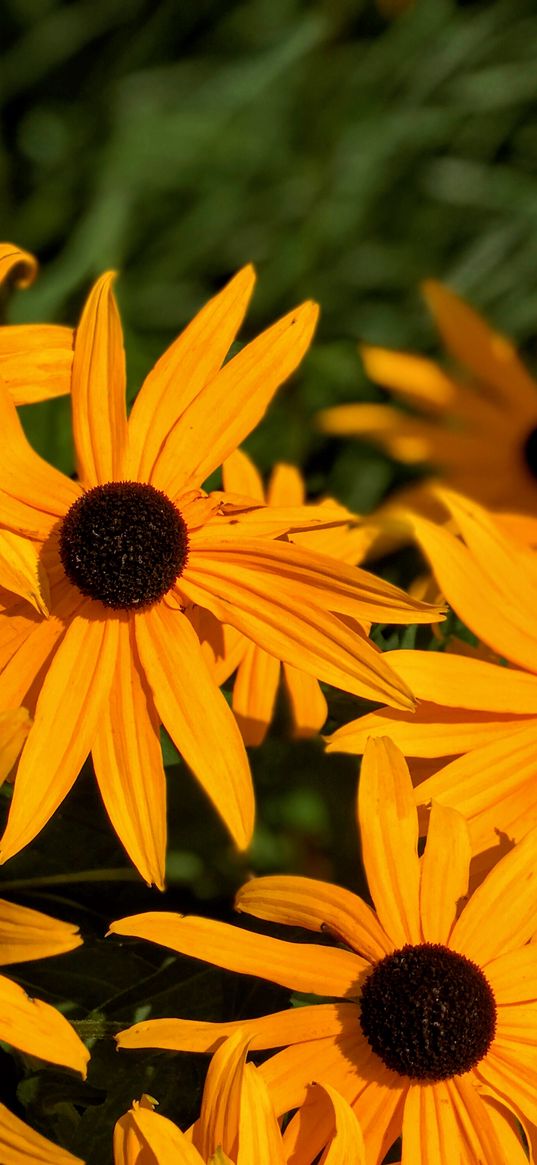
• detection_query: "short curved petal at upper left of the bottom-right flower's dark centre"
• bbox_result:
[235,875,394,962]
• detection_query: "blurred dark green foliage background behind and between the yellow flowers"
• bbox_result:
[0,0,537,1165]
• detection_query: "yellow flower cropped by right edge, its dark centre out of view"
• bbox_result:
[326,489,537,877]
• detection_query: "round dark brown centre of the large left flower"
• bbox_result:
[59,481,189,610]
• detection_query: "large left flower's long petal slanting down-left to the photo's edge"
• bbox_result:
[0,615,118,861]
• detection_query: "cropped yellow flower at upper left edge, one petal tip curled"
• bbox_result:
[0,242,73,404]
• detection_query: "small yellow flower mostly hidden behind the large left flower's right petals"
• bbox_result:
[196,450,369,746]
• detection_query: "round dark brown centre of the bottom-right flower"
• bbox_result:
[360,942,496,1081]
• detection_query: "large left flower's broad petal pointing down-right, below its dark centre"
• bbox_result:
[135,603,255,849]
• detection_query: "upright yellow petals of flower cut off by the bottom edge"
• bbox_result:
[114,1030,365,1165]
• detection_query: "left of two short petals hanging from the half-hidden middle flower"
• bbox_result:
[232,643,280,746]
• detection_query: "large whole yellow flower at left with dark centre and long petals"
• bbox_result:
[0,268,441,887]
